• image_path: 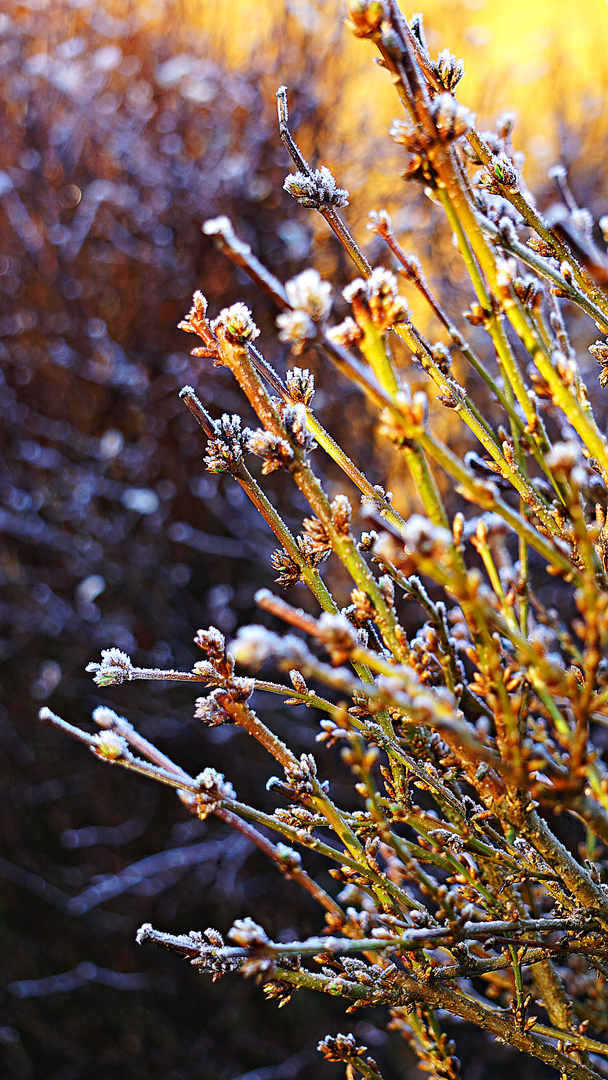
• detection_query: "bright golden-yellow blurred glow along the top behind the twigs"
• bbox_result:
[136,0,608,181]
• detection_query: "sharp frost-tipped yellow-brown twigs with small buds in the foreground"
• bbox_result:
[41,0,608,1080]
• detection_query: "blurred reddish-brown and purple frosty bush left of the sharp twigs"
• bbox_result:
[0,0,371,1080]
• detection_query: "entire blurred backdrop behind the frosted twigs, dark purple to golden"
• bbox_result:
[0,0,608,1080]
